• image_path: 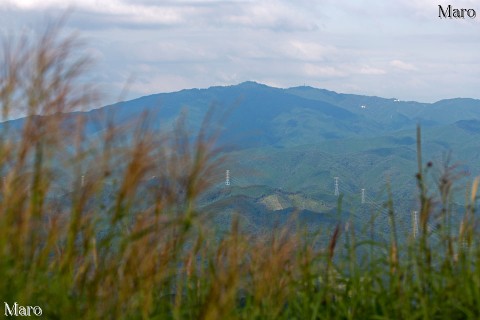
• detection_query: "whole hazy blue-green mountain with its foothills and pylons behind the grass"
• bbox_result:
[4,82,480,235]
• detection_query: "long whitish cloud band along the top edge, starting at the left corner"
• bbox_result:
[0,0,317,31]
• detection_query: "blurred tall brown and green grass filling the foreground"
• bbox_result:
[0,21,480,319]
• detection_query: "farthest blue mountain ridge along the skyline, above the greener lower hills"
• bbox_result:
[47,81,480,147]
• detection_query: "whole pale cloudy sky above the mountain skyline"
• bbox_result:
[0,0,480,102]
